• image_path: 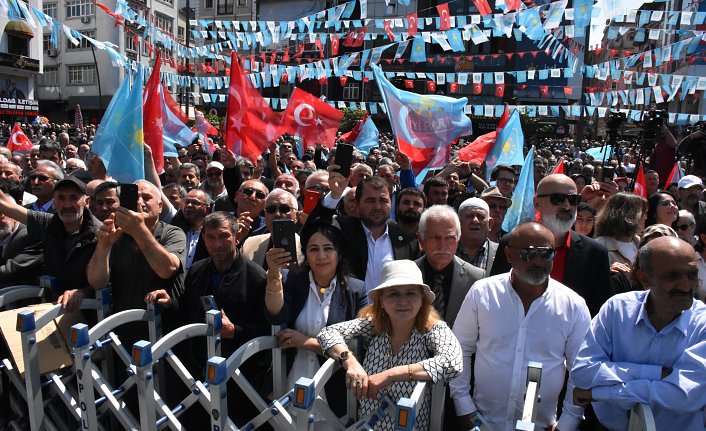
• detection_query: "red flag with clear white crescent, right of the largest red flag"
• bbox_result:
[280,88,343,148]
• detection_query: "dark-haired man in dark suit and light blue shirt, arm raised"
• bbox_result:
[321,175,419,290]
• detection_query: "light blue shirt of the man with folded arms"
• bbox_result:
[571,291,706,431]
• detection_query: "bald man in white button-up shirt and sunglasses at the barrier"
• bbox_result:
[450,223,591,430]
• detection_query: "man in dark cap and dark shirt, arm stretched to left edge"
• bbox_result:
[0,176,100,311]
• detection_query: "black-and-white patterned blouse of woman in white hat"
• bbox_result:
[317,318,463,430]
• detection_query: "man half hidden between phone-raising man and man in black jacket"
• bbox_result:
[171,189,213,272]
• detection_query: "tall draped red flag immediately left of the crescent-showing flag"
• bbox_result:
[223,53,280,163]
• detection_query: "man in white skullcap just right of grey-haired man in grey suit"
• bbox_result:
[456,198,498,277]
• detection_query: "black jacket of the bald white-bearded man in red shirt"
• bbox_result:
[491,230,612,316]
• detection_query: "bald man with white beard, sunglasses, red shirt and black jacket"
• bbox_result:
[490,174,612,316]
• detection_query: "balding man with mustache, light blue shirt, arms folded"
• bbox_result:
[571,237,706,431]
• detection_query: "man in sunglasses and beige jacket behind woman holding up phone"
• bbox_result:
[242,188,304,271]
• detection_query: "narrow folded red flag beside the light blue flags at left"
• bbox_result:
[142,51,164,173]
